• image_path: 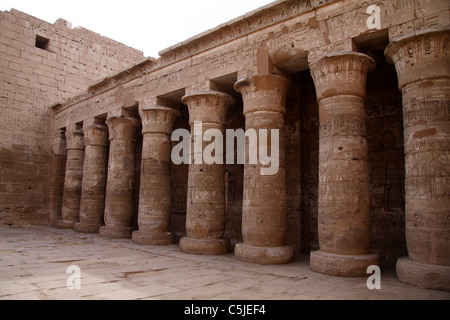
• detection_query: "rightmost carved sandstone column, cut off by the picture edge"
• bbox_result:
[385,30,450,291]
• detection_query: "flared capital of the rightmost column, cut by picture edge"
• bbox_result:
[384,30,450,90]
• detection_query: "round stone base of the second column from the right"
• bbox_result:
[310,250,380,277]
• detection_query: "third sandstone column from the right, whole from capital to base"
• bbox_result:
[234,75,294,264]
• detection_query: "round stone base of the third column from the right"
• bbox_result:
[234,243,294,264]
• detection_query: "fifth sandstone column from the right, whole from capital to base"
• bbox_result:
[133,106,179,245]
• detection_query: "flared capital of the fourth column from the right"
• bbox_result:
[181,90,234,125]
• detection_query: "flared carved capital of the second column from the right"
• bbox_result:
[309,52,375,101]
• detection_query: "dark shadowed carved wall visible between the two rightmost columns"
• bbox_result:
[365,53,406,264]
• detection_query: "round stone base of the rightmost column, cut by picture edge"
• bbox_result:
[396,257,450,291]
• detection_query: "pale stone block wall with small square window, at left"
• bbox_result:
[0,9,144,224]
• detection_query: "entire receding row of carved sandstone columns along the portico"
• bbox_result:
[58,32,450,287]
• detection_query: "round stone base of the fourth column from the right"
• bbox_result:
[180,237,230,255]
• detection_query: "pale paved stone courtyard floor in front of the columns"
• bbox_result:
[0,226,450,300]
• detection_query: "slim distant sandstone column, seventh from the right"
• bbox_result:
[74,118,108,233]
